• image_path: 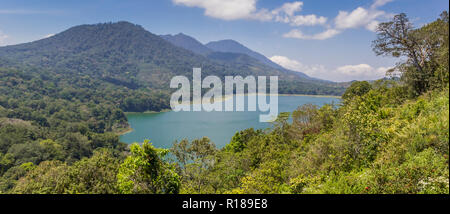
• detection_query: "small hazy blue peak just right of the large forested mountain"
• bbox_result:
[161,33,213,55]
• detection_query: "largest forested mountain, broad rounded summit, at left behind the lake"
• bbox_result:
[0,22,274,89]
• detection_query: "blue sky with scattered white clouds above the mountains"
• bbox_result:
[0,0,449,82]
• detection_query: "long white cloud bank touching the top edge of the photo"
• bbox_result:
[172,0,393,40]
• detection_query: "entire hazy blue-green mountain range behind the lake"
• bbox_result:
[0,21,344,95]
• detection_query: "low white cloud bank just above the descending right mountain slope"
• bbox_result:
[270,56,391,82]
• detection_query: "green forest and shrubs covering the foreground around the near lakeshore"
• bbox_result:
[0,12,449,194]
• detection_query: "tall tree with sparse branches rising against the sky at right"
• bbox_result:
[372,11,449,96]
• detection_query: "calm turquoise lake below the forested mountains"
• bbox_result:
[120,95,340,148]
